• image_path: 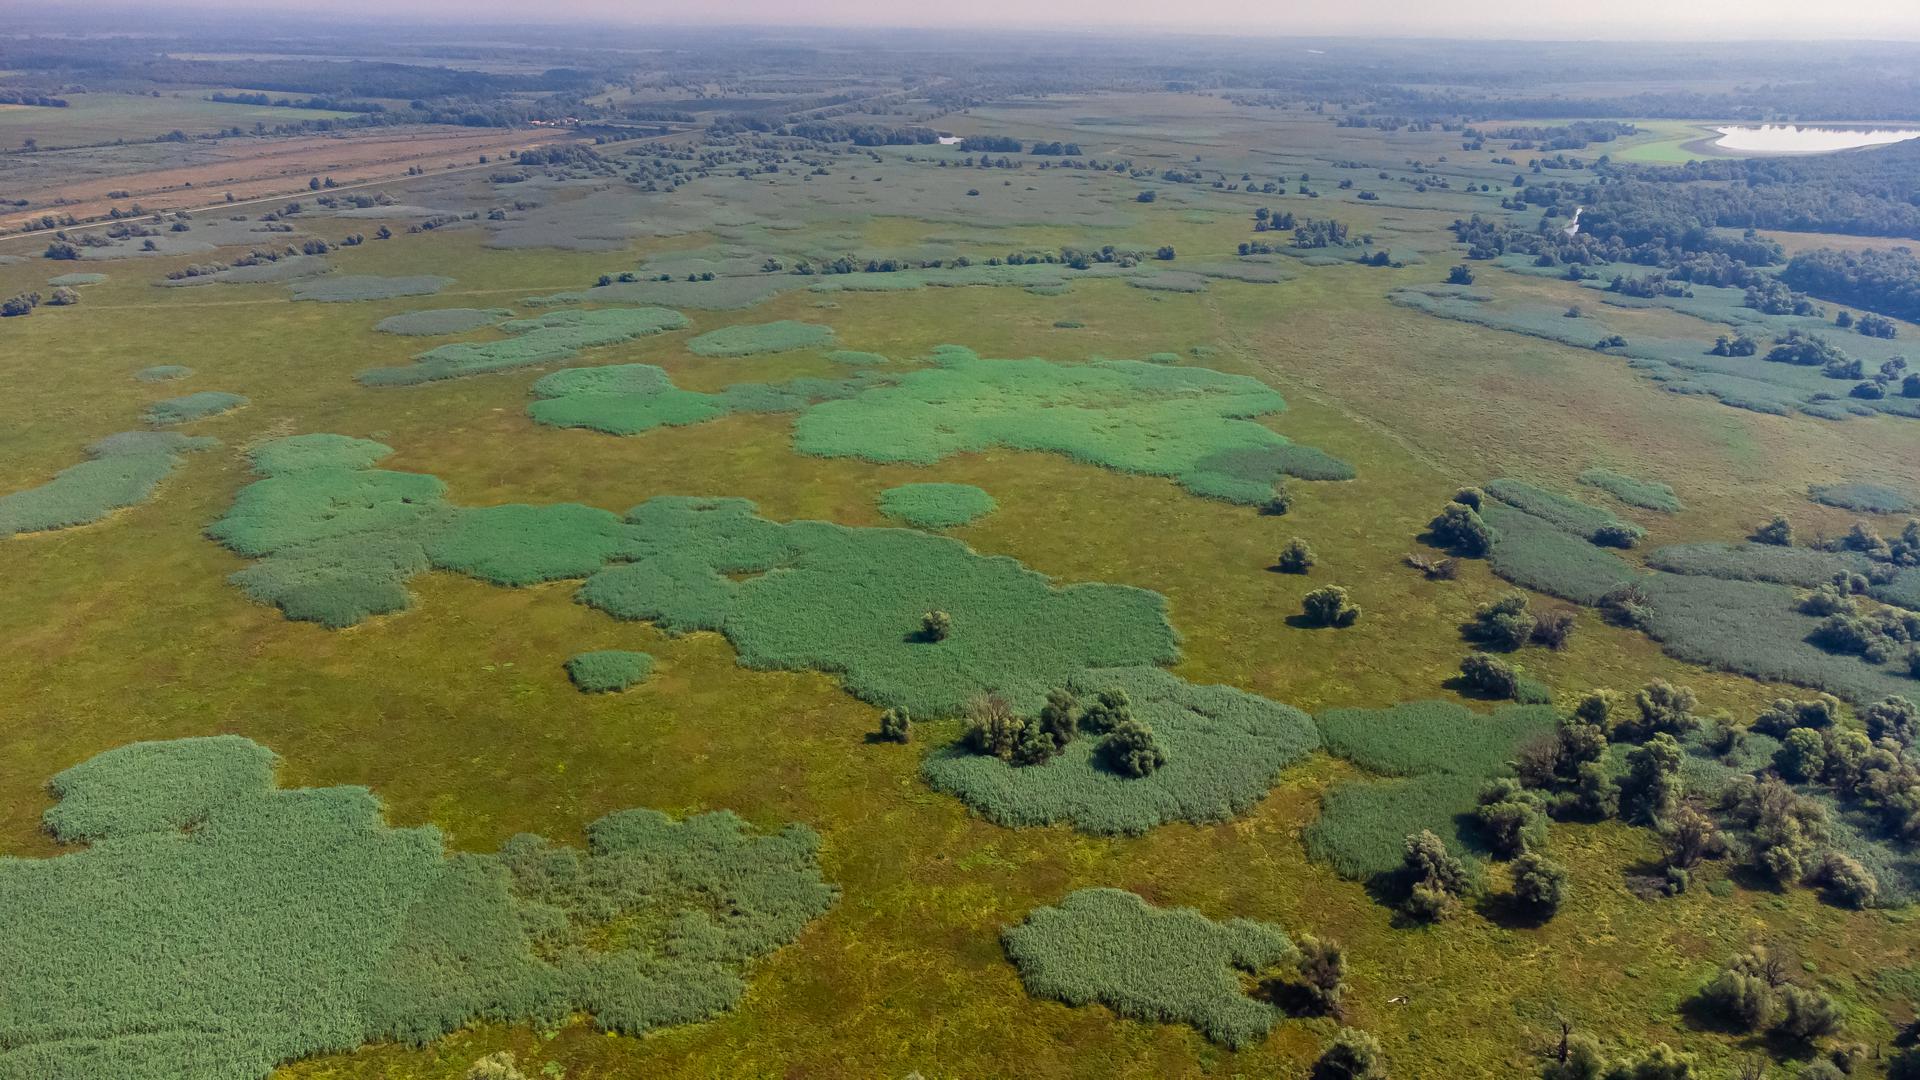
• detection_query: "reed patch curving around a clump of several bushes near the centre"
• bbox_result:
[922,667,1319,834]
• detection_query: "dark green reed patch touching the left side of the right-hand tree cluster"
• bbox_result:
[1306,700,1557,880]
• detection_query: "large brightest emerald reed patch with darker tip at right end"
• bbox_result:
[793,346,1352,503]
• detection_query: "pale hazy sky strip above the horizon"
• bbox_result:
[154,0,1920,40]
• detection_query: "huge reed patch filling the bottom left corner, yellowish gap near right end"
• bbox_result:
[0,736,837,1080]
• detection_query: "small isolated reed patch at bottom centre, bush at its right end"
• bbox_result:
[1000,888,1296,1047]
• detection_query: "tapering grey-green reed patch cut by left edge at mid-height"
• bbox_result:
[0,430,219,536]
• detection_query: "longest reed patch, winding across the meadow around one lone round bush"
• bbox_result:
[207,436,1177,715]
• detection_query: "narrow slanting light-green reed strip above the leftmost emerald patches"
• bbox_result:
[357,307,689,386]
